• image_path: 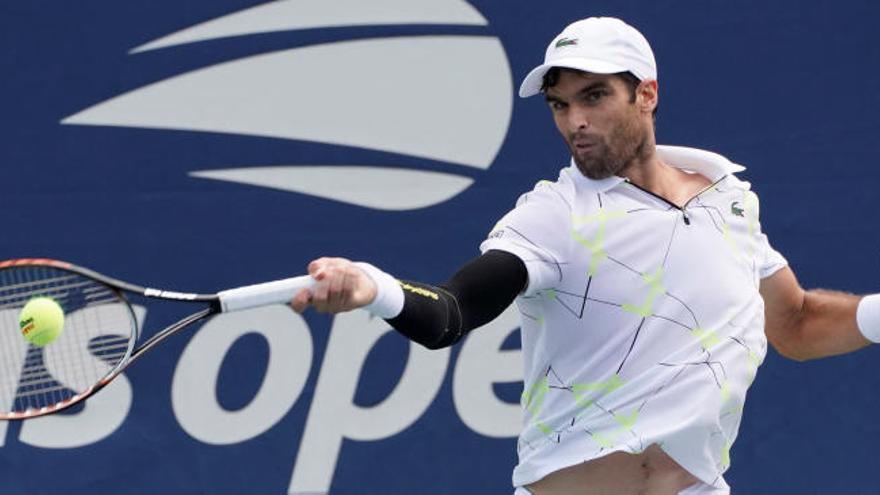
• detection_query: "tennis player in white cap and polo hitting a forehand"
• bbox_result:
[292,18,880,495]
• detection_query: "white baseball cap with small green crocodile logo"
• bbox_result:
[519,17,657,98]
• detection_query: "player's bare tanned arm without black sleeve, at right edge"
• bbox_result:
[760,267,880,361]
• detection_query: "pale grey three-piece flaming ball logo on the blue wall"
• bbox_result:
[61,0,513,210]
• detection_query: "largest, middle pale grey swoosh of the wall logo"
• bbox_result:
[62,36,513,169]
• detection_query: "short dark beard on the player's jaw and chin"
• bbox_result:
[569,120,648,180]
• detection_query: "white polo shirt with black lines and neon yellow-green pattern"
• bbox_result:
[480,146,786,493]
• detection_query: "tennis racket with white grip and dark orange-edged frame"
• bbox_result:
[0,259,314,420]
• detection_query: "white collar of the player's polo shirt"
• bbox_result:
[566,145,746,192]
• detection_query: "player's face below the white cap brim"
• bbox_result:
[545,70,651,179]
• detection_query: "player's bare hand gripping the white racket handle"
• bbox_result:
[290,258,376,313]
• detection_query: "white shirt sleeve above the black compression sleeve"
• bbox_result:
[480,181,571,296]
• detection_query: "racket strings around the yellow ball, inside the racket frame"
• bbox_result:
[0,266,135,416]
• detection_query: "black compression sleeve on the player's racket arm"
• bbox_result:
[388,250,528,349]
